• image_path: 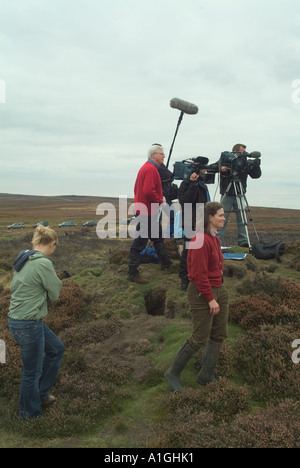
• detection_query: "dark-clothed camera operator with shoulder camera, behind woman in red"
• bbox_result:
[178,156,210,291]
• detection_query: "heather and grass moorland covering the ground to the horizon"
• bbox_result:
[0,194,300,448]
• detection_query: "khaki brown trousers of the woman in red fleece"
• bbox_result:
[187,282,229,351]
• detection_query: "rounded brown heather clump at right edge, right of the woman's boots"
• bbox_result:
[232,325,300,401]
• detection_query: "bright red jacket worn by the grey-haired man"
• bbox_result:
[134,161,163,216]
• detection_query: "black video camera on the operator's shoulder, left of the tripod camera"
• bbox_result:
[173,156,219,184]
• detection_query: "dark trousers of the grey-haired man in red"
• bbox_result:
[128,214,171,276]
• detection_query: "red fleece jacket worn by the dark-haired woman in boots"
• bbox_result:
[187,233,224,302]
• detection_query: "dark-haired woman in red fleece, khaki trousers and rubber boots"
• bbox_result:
[165,202,229,392]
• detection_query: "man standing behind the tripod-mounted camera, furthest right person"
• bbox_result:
[218,143,261,247]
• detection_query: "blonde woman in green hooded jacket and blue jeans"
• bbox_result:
[8,225,64,419]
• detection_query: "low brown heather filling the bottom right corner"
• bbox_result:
[153,400,300,448]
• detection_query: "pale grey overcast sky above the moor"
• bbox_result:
[0,0,300,209]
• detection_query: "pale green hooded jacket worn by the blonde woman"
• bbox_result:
[8,251,62,320]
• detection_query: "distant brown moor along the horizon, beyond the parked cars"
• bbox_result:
[0,193,300,240]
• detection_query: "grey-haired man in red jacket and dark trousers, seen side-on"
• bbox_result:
[127,144,172,284]
